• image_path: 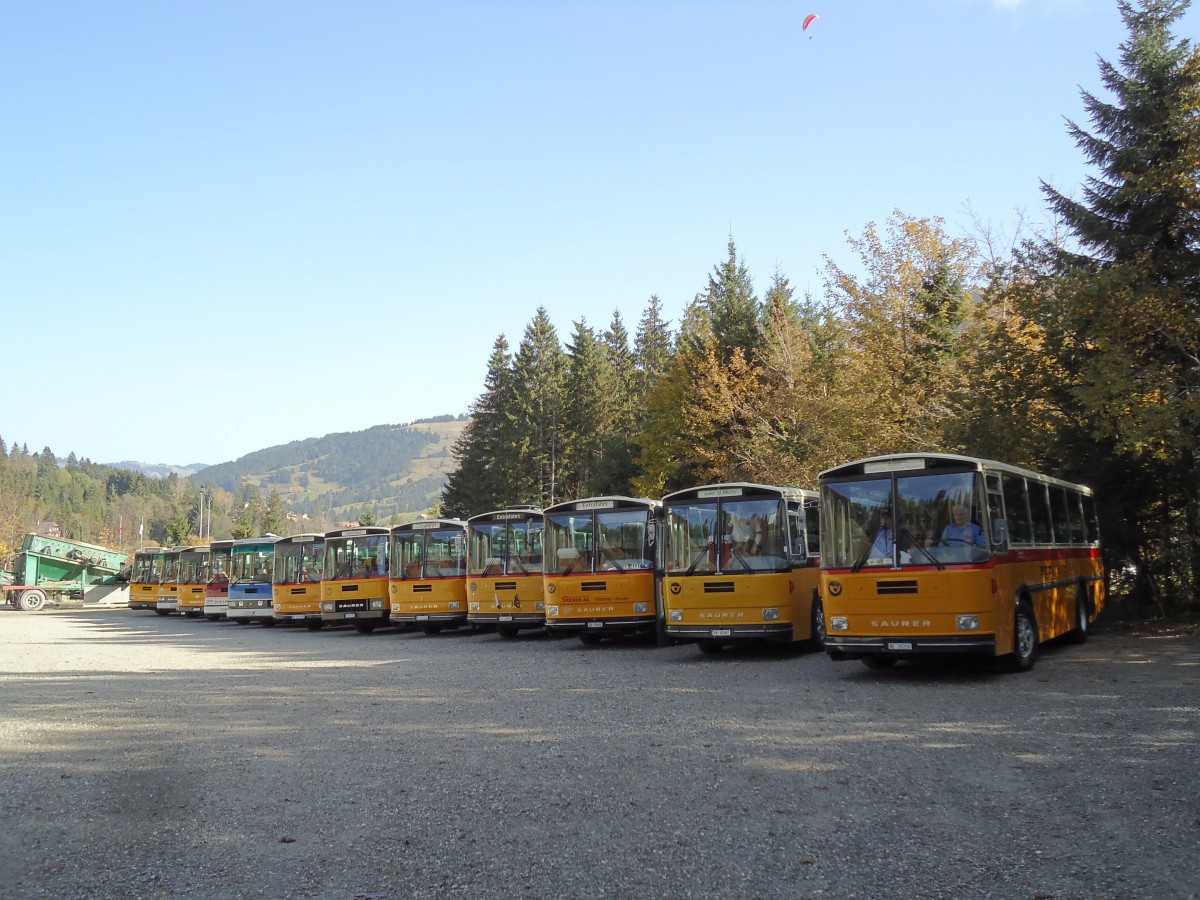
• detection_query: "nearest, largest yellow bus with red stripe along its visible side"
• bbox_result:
[820,454,1108,671]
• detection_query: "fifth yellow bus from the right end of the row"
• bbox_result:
[389,518,467,635]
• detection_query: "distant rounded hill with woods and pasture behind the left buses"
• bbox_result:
[192,415,468,521]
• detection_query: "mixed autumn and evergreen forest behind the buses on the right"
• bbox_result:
[443,0,1200,614]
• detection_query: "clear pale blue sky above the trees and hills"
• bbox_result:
[0,0,1180,464]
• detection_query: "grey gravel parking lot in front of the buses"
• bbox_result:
[0,608,1200,900]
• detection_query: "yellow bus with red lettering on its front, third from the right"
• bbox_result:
[544,497,662,644]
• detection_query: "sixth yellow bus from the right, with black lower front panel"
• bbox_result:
[320,526,391,635]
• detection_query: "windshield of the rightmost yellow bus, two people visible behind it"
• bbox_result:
[822,470,989,569]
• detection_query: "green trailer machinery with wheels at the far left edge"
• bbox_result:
[0,534,128,610]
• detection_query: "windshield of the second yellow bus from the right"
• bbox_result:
[666,497,790,575]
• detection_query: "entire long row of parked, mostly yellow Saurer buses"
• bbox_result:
[130,454,1106,670]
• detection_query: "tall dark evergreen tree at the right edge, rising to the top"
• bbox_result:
[1039,0,1200,608]
